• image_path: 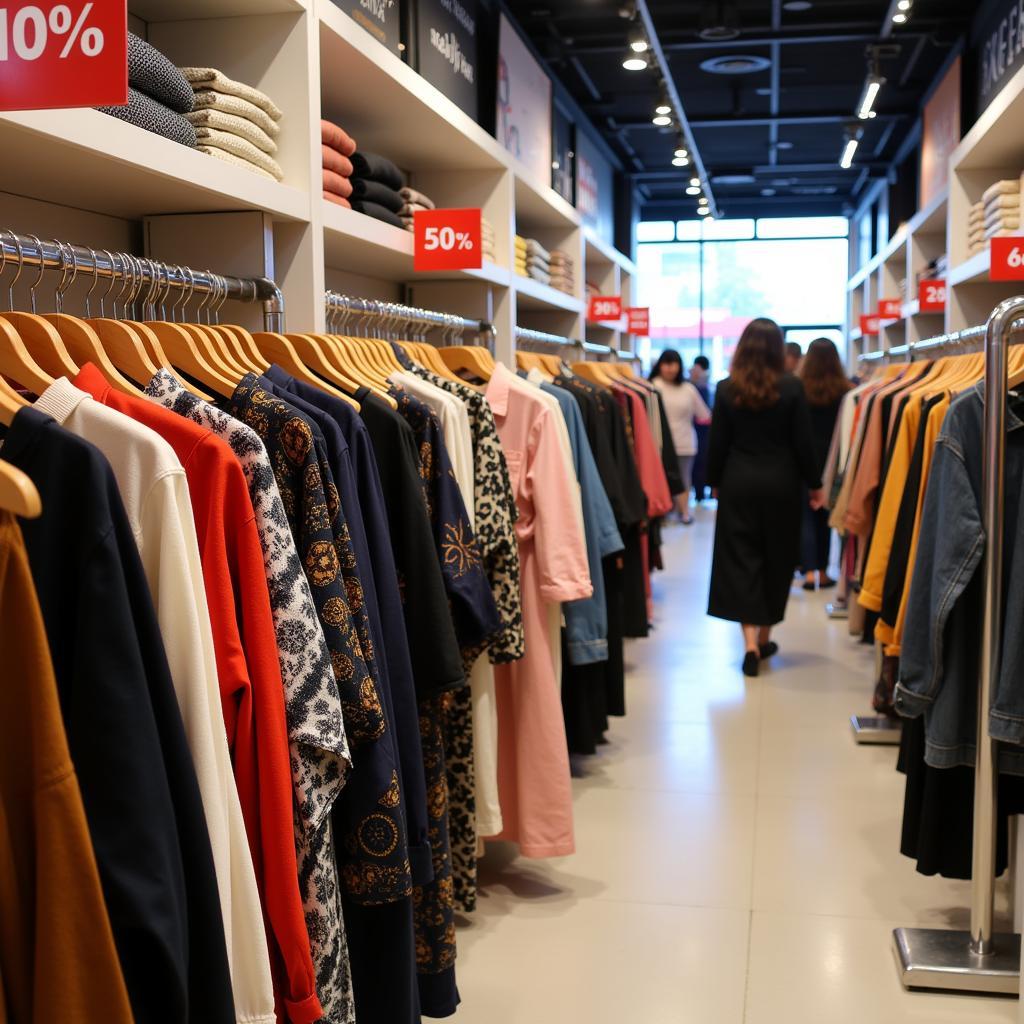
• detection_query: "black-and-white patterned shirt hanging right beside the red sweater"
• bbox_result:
[145,370,354,1022]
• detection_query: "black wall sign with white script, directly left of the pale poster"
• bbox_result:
[416,0,479,121]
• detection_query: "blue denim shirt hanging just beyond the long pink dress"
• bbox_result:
[541,382,624,665]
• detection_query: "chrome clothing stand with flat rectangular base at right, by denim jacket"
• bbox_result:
[893,297,1024,993]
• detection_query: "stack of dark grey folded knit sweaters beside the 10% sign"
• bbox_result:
[96,32,197,147]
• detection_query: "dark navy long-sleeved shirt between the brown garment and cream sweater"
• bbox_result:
[2,409,236,1024]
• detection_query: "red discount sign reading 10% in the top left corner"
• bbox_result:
[0,0,128,111]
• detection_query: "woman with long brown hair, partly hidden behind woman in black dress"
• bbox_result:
[800,338,853,590]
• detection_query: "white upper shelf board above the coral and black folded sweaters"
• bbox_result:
[315,0,510,173]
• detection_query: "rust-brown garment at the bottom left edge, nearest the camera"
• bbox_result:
[0,510,132,1024]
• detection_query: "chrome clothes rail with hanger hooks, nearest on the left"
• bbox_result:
[0,231,285,332]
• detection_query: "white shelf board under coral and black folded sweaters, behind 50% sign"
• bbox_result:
[324,201,509,288]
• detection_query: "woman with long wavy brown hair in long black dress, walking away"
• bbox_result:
[708,319,824,676]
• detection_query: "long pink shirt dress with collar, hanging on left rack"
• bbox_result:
[486,364,593,857]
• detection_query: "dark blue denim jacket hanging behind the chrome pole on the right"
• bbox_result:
[896,384,1024,774]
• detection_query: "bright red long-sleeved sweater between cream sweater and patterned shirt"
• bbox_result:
[74,364,323,1024]
